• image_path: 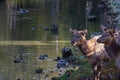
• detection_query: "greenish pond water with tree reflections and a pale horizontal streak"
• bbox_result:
[0,0,99,80]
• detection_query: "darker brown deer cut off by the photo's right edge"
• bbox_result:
[97,26,120,70]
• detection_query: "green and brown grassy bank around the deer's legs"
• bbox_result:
[53,58,118,80]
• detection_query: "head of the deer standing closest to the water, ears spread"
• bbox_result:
[69,28,87,46]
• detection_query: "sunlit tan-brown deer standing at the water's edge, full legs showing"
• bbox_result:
[69,28,110,80]
